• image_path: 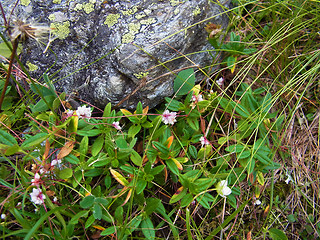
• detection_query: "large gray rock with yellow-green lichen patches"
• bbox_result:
[1,0,228,109]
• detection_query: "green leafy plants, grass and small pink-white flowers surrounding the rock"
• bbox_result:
[0,0,320,239]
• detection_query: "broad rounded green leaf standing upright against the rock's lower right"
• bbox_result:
[173,68,196,96]
